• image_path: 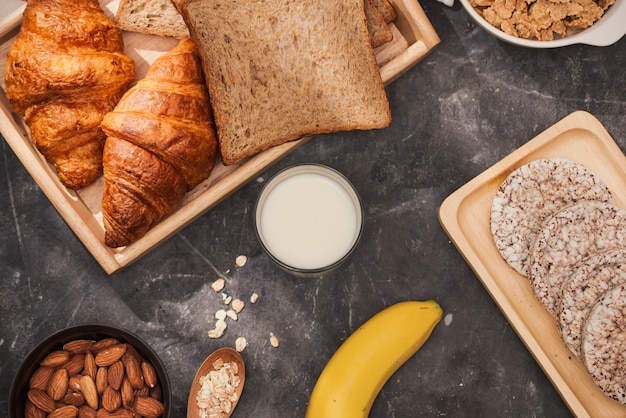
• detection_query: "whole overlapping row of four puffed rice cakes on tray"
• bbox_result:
[491,158,626,404]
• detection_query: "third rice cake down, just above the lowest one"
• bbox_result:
[558,248,626,357]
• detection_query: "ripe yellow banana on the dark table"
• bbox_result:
[306,300,443,418]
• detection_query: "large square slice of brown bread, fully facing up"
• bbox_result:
[174,0,391,165]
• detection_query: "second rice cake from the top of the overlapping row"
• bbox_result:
[530,200,626,317]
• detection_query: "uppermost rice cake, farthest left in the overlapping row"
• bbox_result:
[491,158,612,276]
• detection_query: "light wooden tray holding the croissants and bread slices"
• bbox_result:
[0,0,440,274]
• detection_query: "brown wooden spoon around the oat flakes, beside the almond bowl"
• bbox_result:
[187,347,246,418]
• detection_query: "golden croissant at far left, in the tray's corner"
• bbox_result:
[5,0,135,189]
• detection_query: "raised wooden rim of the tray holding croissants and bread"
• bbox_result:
[0,0,439,274]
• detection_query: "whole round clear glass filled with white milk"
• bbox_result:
[254,164,363,277]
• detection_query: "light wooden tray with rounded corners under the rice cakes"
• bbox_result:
[439,111,626,418]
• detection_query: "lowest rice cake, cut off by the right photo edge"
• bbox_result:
[582,285,626,404]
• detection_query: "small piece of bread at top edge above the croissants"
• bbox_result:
[115,0,189,39]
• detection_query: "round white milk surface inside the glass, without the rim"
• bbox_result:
[259,172,361,269]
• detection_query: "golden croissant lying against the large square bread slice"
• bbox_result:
[102,38,217,248]
